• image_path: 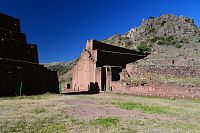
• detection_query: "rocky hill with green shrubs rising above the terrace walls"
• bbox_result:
[103,14,200,66]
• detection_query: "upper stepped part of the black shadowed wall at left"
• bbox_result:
[0,14,38,63]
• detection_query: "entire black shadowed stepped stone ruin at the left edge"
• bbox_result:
[0,13,59,96]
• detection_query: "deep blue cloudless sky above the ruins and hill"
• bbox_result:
[0,0,200,63]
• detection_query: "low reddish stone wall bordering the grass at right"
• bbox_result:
[112,82,200,98]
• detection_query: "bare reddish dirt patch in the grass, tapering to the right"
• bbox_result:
[64,94,175,121]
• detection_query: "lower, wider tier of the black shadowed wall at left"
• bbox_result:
[0,59,59,96]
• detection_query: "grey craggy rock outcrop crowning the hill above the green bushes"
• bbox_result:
[127,14,197,42]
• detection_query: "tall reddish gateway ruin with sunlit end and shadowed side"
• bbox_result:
[72,40,147,91]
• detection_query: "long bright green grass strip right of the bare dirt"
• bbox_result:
[118,102,173,114]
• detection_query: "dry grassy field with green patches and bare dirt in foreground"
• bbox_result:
[0,94,200,133]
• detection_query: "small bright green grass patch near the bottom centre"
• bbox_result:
[95,117,120,127]
